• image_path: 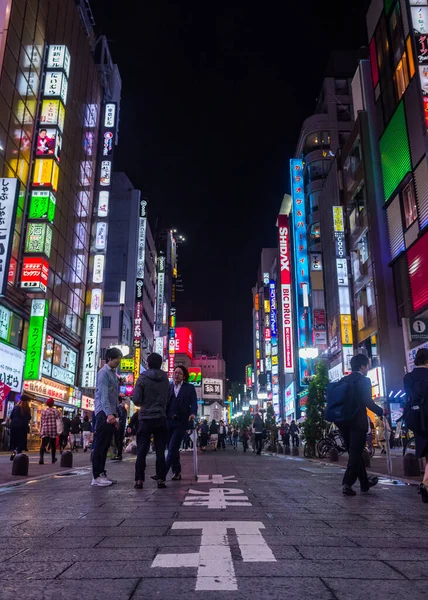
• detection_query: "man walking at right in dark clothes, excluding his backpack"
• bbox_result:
[336,354,383,496]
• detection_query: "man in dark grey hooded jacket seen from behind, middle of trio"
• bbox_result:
[133,352,169,489]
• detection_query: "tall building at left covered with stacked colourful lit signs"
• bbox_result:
[0,0,120,444]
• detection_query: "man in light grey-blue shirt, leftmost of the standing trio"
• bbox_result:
[92,348,122,487]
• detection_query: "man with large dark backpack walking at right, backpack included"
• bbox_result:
[325,354,383,496]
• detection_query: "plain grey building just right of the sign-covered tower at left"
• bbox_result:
[101,173,156,372]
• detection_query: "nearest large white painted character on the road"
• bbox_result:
[152,521,276,591]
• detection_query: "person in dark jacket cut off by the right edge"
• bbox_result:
[404,348,428,503]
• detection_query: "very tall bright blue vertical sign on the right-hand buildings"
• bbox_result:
[290,159,311,385]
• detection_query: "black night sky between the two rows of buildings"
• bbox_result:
[91,0,369,380]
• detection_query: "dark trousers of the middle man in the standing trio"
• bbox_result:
[135,418,168,481]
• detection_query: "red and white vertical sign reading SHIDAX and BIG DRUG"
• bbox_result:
[278,215,294,373]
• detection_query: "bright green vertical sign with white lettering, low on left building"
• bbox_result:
[24,299,49,380]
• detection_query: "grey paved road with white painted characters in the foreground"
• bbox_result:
[0,449,428,600]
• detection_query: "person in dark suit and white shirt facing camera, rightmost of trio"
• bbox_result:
[166,365,198,481]
